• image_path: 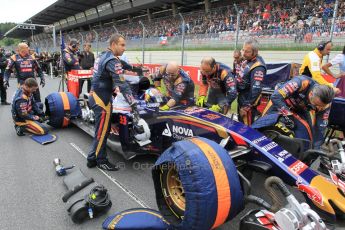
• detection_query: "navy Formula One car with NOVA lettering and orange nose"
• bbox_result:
[46,73,345,229]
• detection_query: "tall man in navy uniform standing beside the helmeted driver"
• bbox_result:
[87,34,141,171]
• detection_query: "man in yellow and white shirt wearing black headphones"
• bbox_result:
[299,41,340,94]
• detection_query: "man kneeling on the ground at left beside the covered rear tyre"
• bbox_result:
[12,78,48,136]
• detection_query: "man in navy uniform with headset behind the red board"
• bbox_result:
[62,38,81,72]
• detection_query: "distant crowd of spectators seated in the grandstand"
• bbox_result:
[30,0,345,46]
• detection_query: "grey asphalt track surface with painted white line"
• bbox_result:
[0,78,342,230]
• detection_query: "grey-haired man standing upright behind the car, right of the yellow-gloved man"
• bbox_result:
[236,39,266,125]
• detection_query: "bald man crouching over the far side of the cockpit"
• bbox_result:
[153,62,194,111]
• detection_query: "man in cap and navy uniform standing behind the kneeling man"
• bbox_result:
[4,43,45,102]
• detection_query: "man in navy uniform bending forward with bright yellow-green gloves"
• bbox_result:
[196,57,237,114]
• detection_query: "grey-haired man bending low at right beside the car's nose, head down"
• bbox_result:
[253,75,335,149]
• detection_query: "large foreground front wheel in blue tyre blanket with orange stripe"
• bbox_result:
[152,137,244,230]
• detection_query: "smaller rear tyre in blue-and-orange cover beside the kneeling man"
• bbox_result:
[45,92,81,128]
